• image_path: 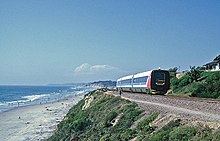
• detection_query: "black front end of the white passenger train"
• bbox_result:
[151,70,170,94]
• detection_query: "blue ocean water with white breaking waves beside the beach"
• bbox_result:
[0,86,94,112]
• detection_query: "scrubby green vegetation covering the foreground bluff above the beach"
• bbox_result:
[48,90,220,141]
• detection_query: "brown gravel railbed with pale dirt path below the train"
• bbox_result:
[108,91,220,122]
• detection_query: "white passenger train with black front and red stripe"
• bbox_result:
[116,70,170,94]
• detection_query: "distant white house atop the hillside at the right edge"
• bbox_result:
[204,55,220,71]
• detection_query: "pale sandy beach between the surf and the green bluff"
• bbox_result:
[0,95,83,141]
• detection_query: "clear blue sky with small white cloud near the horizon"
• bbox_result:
[0,0,220,85]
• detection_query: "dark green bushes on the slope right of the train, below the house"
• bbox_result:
[171,67,220,98]
